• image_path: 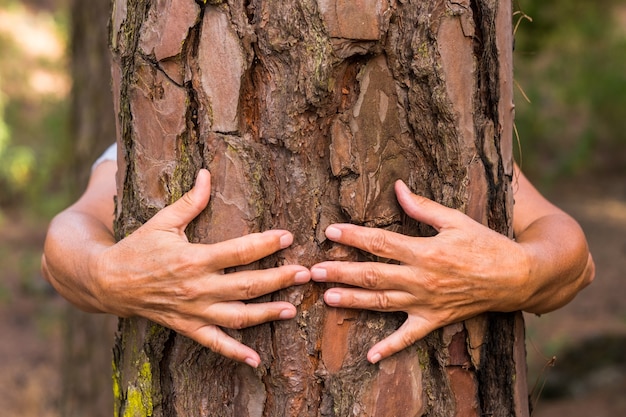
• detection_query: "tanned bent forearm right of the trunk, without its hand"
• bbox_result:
[516,212,595,314]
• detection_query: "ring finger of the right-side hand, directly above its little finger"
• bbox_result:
[324,288,415,312]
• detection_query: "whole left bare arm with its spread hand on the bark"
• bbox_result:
[42,162,310,366]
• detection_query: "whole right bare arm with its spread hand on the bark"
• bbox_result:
[311,165,594,362]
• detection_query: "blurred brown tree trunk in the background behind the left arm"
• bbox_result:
[60,0,117,417]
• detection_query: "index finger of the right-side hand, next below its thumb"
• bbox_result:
[325,224,420,262]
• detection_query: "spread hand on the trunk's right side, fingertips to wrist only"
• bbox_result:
[311,181,529,363]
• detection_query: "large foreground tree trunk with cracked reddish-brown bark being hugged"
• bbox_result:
[111,0,528,417]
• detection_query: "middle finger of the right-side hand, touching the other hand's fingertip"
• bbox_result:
[311,261,416,291]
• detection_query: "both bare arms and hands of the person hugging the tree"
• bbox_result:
[42,161,594,367]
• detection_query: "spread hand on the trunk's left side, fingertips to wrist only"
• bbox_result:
[94,170,310,367]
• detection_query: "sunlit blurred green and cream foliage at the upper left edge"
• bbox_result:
[0,0,70,217]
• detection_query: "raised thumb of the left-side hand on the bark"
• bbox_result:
[149,169,211,233]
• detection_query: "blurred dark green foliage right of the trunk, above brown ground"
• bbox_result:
[515,0,626,179]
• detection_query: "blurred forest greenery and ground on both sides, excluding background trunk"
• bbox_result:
[0,0,626,417]
